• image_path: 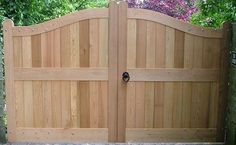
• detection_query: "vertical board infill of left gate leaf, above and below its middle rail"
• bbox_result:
[13,18,108,133]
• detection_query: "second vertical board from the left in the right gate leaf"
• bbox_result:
[135,20,147,128]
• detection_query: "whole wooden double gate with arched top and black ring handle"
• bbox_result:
[4,2,230,142]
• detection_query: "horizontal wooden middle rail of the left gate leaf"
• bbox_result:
[15,68,108,81]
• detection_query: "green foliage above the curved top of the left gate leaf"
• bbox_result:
[0,0,107,26]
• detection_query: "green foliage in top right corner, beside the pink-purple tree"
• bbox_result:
[190,0,236,28]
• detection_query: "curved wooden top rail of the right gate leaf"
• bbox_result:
[127,8,223,38]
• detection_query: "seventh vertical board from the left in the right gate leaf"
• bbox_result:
[181,34,194,128]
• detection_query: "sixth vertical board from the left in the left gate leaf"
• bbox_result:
[60,26,71,128]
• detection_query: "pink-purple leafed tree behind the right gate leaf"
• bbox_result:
[126,0,197,21]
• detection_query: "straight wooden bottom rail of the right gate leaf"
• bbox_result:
[126,128,216,142]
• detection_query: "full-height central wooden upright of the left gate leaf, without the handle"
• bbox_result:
[108,2,118,142]
